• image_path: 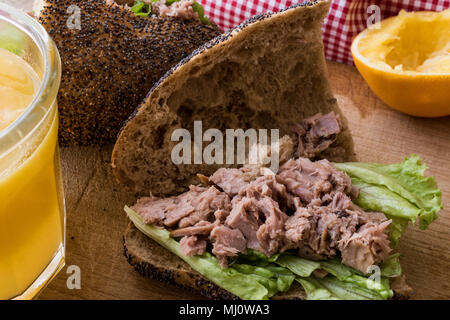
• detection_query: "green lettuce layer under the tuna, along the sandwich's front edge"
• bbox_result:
[125,207,401,300]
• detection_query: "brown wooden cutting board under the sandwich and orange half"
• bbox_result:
[40,63,450,299]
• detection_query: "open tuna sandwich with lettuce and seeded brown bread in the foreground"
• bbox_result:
[112,1,441,299]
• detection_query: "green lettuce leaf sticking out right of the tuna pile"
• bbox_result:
[334,155,442,230]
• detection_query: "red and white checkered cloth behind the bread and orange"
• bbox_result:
[197,0,450,64]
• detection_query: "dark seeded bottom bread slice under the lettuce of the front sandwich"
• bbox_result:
[123,222,411,300]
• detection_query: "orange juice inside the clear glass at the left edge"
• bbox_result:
[0,49,64,299]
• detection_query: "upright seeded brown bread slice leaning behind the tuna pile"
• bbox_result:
[112,1,354,196]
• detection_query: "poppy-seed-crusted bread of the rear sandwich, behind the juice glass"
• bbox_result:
[34,0,221,145]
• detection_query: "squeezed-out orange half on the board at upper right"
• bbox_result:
[351,9,450,117]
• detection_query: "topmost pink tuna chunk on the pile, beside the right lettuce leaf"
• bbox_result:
[277,158,355,206]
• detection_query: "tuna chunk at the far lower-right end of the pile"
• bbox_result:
[341,220,391,272]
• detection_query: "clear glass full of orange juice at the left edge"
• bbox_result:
[0,3,65,299]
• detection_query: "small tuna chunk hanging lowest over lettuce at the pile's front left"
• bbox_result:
[210,225,247,267]
